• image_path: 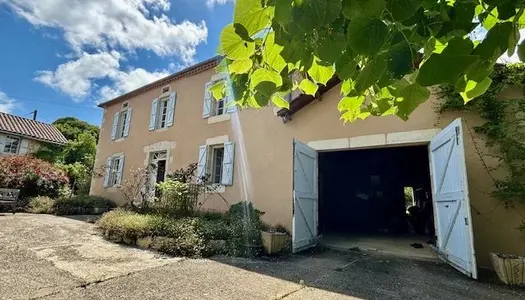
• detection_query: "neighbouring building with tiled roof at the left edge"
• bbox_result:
[0,112,67,157]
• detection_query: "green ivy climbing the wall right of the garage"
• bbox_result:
[439,63,525,231]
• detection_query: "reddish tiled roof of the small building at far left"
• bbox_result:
[0,112,67,144]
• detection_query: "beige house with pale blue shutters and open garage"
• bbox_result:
[91,58,525,277]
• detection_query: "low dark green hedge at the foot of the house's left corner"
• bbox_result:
[54,195,116,215]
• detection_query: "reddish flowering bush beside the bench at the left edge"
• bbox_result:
[0,155,69,199]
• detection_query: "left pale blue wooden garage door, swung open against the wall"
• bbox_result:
[292,140,318,253]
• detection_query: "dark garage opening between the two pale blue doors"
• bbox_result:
[318,145,435,258]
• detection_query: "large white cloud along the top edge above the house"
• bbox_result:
[5,0,209,62]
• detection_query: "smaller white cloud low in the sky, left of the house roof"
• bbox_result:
[35,51,121,101]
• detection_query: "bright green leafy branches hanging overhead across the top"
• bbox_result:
[212,0,525,122]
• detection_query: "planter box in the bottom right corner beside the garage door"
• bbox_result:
[490,253,525,286]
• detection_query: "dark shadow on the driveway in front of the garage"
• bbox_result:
[209,248,525,299]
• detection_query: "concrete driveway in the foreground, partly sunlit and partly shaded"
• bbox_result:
[0,214,525,300]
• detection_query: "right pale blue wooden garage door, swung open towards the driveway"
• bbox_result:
[430,119,477,278]
